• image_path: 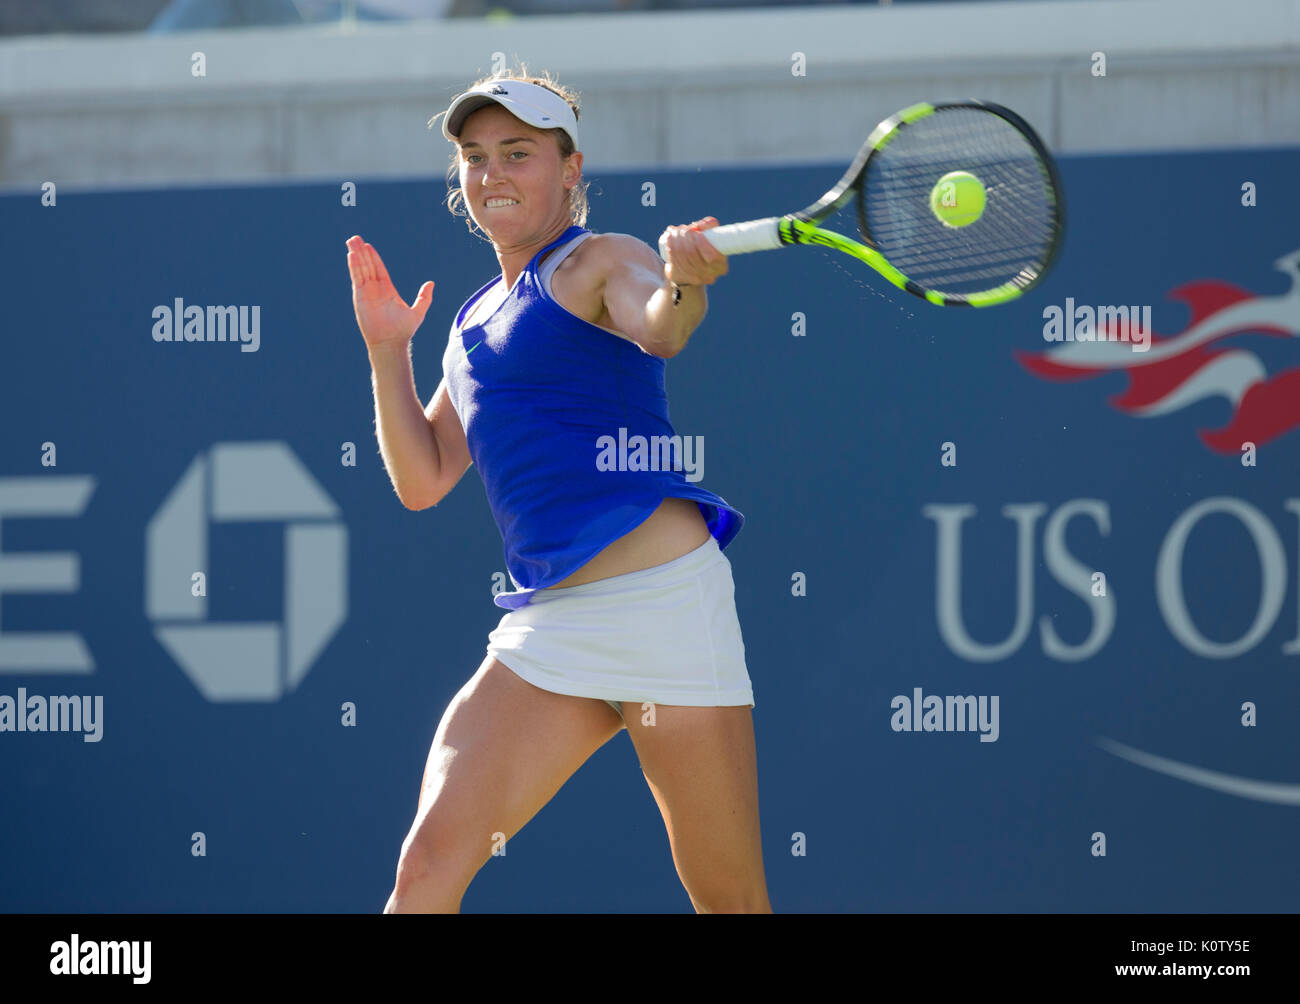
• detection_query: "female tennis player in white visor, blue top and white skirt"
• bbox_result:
[347,70,771,913]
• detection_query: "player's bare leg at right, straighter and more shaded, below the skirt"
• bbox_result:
[623,701,771,910]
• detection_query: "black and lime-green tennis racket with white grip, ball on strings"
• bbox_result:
[659,100,1065,307]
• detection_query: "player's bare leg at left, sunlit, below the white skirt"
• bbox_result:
[384,655,623,913]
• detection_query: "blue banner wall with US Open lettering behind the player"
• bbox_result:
[0,150,1300,912]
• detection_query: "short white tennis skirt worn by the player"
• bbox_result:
[488,537,754,715]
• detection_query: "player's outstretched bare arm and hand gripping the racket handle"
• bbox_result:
[599,216,728,359]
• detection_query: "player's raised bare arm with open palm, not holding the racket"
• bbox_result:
[347,237,469,510]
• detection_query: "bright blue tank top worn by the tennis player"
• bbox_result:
[442,226,745,610]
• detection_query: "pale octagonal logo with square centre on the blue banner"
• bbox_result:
[144,442,347,701]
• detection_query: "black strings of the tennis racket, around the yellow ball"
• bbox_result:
[859,107,1058,294]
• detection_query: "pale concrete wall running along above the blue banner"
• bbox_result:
[0,0,1300,190]
